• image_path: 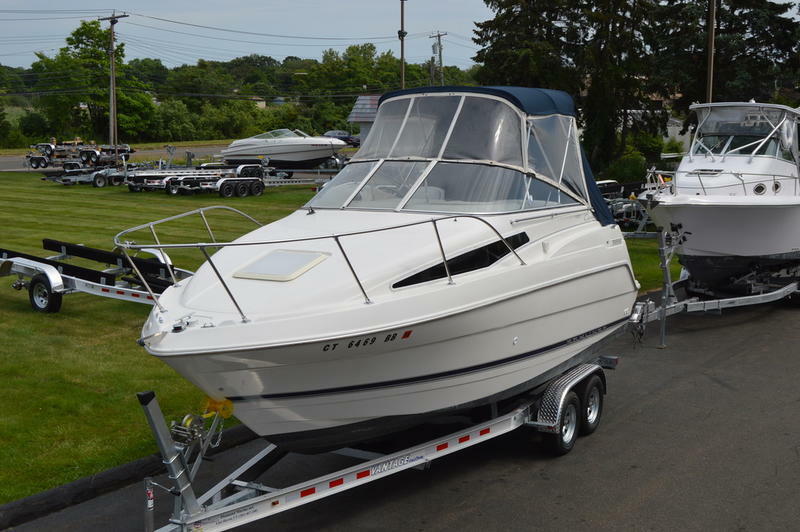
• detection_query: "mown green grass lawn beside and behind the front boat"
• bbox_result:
[0,172,661,504]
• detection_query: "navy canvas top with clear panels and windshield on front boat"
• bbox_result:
[307,87,613,224]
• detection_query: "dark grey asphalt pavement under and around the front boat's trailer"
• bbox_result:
[6,302,800,532]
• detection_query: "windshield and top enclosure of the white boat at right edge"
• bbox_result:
[692,105,797,161]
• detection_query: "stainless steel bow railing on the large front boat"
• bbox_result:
[114,205,525,322]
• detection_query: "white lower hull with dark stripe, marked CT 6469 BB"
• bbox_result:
[155,266,635,451]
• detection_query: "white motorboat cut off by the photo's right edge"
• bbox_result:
[643,102,800,291]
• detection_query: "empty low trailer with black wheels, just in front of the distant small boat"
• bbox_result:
[125,164,269,198]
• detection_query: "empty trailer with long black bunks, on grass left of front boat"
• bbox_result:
[0,238,192,312]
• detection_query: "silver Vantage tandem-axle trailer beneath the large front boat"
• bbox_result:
[138,354,617,532]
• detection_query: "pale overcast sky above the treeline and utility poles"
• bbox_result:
[0,0,492,68]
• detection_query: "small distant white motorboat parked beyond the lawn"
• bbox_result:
[222,129,347,168]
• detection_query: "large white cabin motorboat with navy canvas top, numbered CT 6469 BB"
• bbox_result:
[116,87,638,450]
